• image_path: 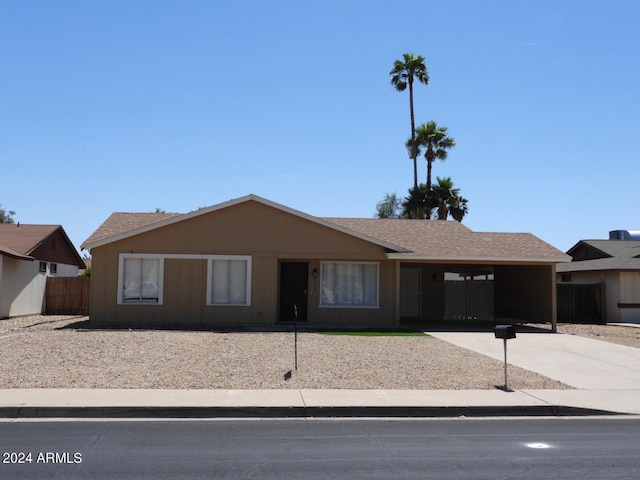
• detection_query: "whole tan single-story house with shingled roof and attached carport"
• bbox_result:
[82,195,570,327]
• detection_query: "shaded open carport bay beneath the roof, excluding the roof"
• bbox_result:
[398,261,557,329]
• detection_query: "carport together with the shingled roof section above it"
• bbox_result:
[304,218,571,329]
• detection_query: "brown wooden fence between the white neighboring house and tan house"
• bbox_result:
[45,277,91,315]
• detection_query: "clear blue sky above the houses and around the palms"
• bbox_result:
[0,0,640,255]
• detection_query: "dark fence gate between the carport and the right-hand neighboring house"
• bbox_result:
[557,283,605,323]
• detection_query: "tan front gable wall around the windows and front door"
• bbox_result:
[90,201,396,326]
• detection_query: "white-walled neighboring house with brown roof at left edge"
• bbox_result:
[0,223,84,318]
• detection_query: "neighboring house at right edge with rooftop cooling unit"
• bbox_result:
[557,230,640,323]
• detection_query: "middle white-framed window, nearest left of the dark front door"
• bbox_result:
[207,255,251,306]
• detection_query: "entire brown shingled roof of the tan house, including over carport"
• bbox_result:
[81,195,570,263]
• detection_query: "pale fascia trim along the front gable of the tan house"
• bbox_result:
[83,194,409,252]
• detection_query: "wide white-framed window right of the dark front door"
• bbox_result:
[320,262,378,308]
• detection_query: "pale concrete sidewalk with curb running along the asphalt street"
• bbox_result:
[0,389,640,418]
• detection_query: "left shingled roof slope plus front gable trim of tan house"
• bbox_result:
[81,195,405,252]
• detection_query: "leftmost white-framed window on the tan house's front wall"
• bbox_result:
[118,255,164,304]
